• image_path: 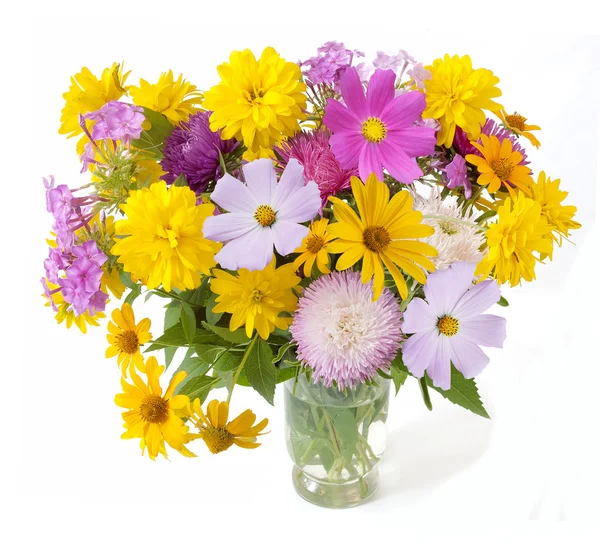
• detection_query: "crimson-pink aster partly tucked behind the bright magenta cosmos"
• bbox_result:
[275,128,358,206]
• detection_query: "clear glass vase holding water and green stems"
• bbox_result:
[285,374,390,507]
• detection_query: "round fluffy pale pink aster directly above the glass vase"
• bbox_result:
[290,271,402,390]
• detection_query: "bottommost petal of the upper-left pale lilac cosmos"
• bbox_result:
[215,225,273,271]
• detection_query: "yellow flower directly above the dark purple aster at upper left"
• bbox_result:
[129,70,202,125]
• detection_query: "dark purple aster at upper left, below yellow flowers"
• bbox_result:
[160,111,238,195]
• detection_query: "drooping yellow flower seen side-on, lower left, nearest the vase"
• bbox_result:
[189,398,269,454]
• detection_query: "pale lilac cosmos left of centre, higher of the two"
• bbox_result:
[203,159,321,271]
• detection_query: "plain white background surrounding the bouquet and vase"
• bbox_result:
[0,1,600,544]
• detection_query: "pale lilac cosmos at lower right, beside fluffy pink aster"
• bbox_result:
[402,261,506,390]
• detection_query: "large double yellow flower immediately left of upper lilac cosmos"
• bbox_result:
[111,182,221,291]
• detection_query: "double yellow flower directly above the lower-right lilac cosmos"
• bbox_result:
[475,193,552,286]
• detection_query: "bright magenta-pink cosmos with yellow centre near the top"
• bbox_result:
[323,67,436,184]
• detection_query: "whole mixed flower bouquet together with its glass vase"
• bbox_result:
[42,42,580,507]
